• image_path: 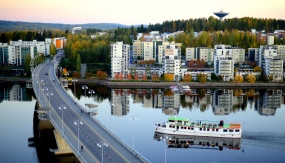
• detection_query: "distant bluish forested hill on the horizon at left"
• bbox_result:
[0,20,129,32]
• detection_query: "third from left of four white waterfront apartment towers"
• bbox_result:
[214,45,234,81]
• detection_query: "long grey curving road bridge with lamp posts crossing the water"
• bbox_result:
[30,54,149,163]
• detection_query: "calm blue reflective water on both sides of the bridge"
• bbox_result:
[0,84,285,163]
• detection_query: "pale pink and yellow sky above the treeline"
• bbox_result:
[0,0,285,25]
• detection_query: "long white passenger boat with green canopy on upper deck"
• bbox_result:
[155,117,242,138]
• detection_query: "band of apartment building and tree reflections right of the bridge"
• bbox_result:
[105,89,284,116]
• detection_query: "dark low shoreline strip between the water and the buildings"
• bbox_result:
[0,77,285,88]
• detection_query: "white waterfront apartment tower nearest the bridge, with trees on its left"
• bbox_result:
[111,42,130,78]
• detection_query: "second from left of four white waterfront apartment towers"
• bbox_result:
[163,44,181,81]
